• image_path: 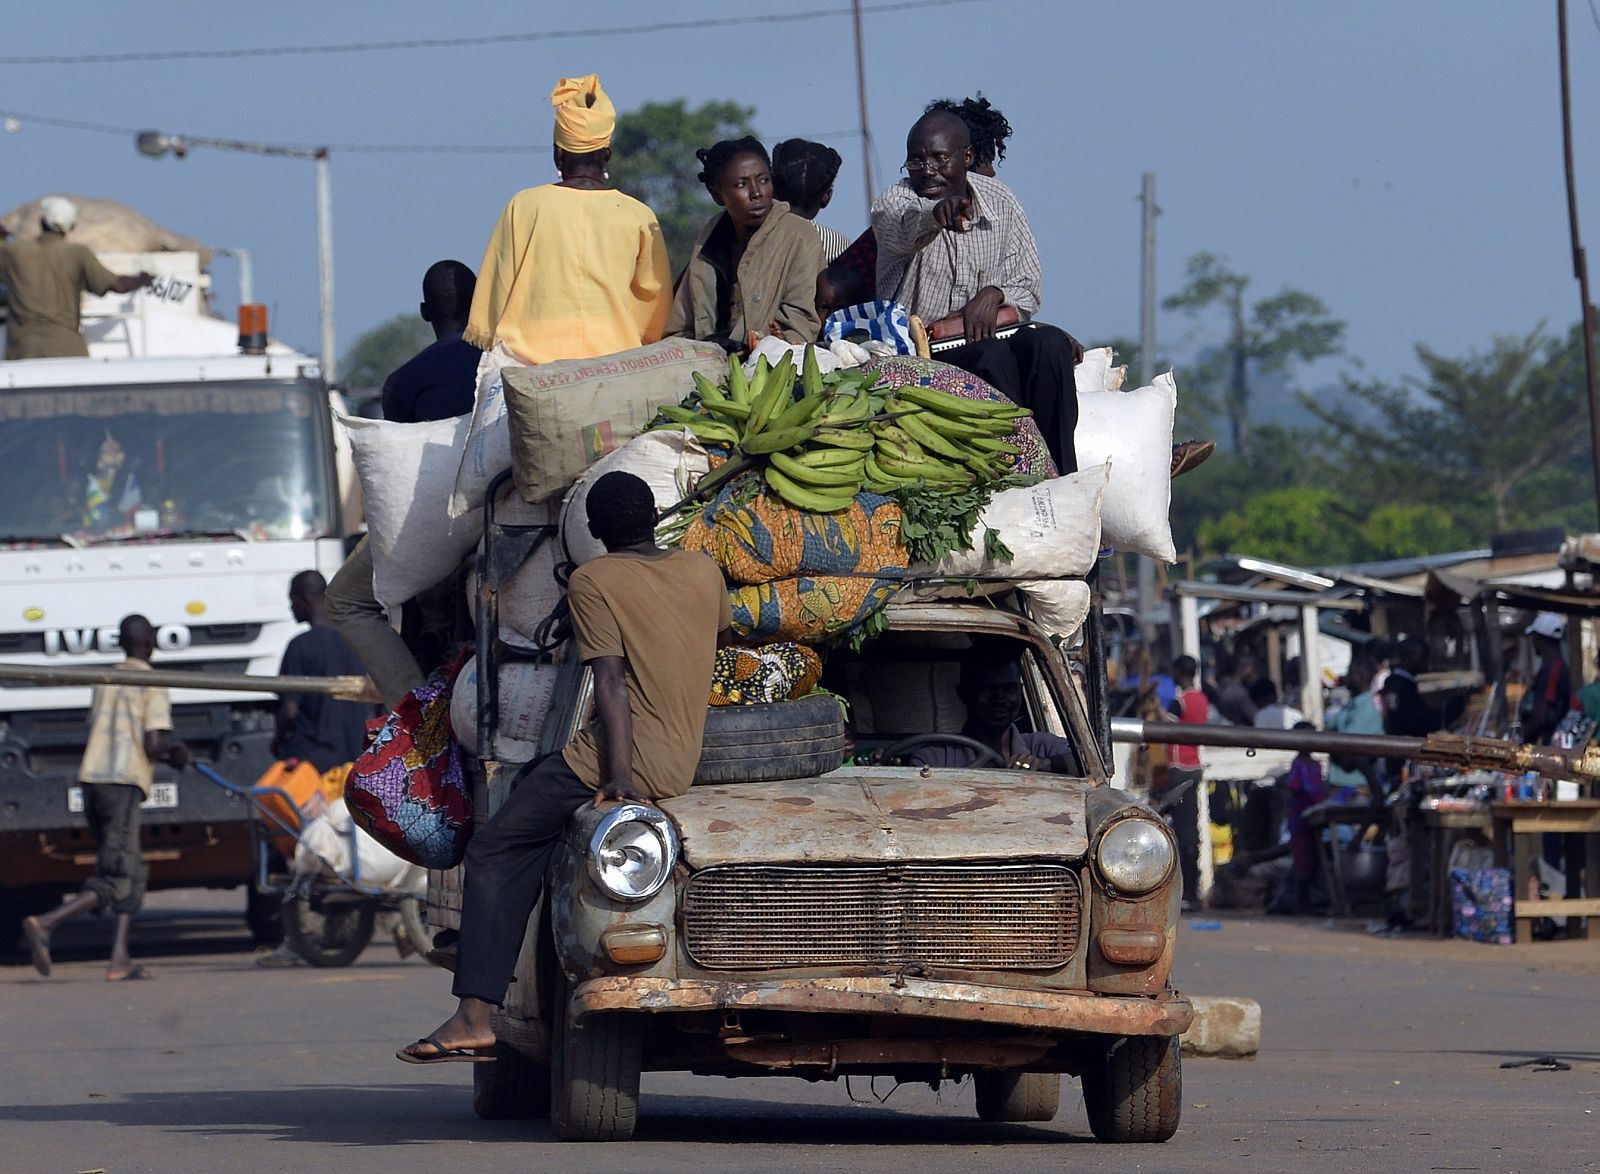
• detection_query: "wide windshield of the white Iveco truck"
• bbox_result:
[0,384,333,545]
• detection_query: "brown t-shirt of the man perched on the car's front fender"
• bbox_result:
[565,550,733,800]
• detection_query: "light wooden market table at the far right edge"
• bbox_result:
[1490,800,1600,945]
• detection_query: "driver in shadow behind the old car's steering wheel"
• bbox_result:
[907,640,1083,776]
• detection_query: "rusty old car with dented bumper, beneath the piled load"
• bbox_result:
[435,585,1192,1142]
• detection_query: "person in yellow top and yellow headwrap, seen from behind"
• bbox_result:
[466,74,672,363]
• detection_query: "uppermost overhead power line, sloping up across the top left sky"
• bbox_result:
[0,0,987,66]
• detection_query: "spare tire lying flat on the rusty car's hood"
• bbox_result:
[694,694,846,782]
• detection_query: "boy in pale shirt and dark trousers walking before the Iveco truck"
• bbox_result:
[22,616,189,982]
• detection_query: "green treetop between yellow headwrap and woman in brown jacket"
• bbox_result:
[610,98,755,272]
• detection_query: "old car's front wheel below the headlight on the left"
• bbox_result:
[547,968,645,1142]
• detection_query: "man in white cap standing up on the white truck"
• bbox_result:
[0,195,154,358]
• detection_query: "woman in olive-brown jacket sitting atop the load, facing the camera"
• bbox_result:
[667,138,826,350]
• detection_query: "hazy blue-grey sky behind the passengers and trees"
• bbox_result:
[0,0,1600,388]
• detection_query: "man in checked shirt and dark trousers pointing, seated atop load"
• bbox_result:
[872,110,1083,473]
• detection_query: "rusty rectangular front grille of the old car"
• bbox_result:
[683,864,1082,969]
